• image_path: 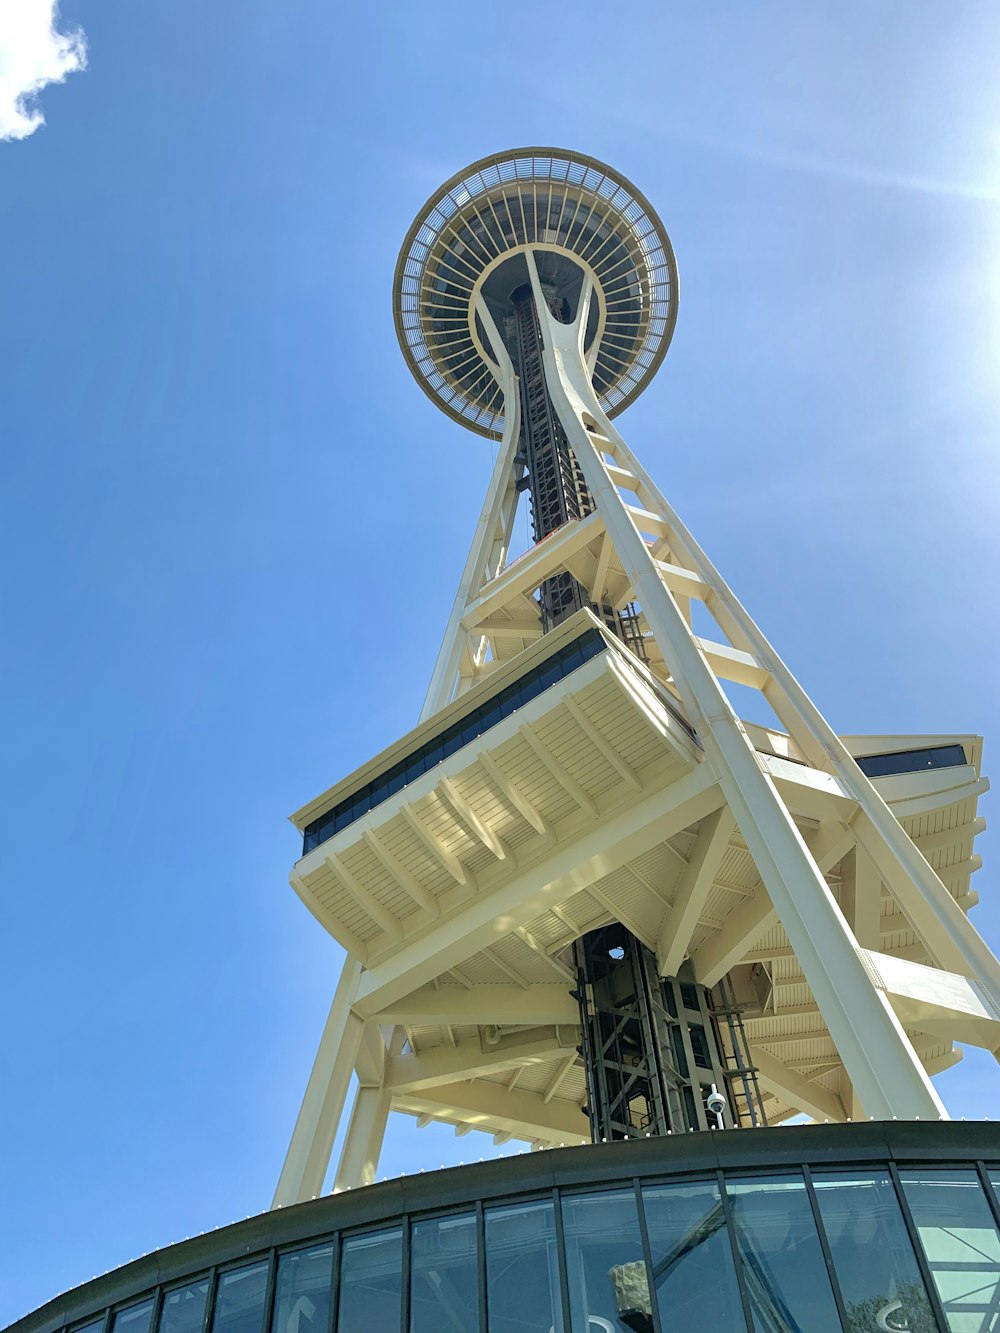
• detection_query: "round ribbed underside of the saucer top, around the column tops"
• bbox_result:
[393,148,677,437]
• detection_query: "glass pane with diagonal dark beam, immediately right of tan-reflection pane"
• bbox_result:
[643,1181,747,1333]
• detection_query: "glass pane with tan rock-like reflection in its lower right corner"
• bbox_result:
[563,1189,653,1333]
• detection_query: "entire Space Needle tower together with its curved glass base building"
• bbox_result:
[15,148,1000,1333]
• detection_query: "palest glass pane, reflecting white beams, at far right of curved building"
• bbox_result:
[901,1170,1000,1333]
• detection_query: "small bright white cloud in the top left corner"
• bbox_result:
[0,0,87,139]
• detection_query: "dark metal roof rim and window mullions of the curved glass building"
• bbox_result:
[21,1122,1000,1333]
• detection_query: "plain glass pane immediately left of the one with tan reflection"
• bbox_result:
[485,1200,563,1333]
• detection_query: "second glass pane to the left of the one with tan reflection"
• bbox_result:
[409,1213,479,1333]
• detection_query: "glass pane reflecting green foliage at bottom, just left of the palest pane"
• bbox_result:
[812,1170,937,1333]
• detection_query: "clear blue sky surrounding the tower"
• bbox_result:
[0,0,1000,1322]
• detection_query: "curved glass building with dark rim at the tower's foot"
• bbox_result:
[9,1122,1000,1333]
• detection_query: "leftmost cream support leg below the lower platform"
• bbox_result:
[271,954,364,1208]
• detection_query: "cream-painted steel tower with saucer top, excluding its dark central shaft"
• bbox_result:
[275,149,1000,1204]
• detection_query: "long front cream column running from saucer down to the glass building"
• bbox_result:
[527,252,944,1118]
